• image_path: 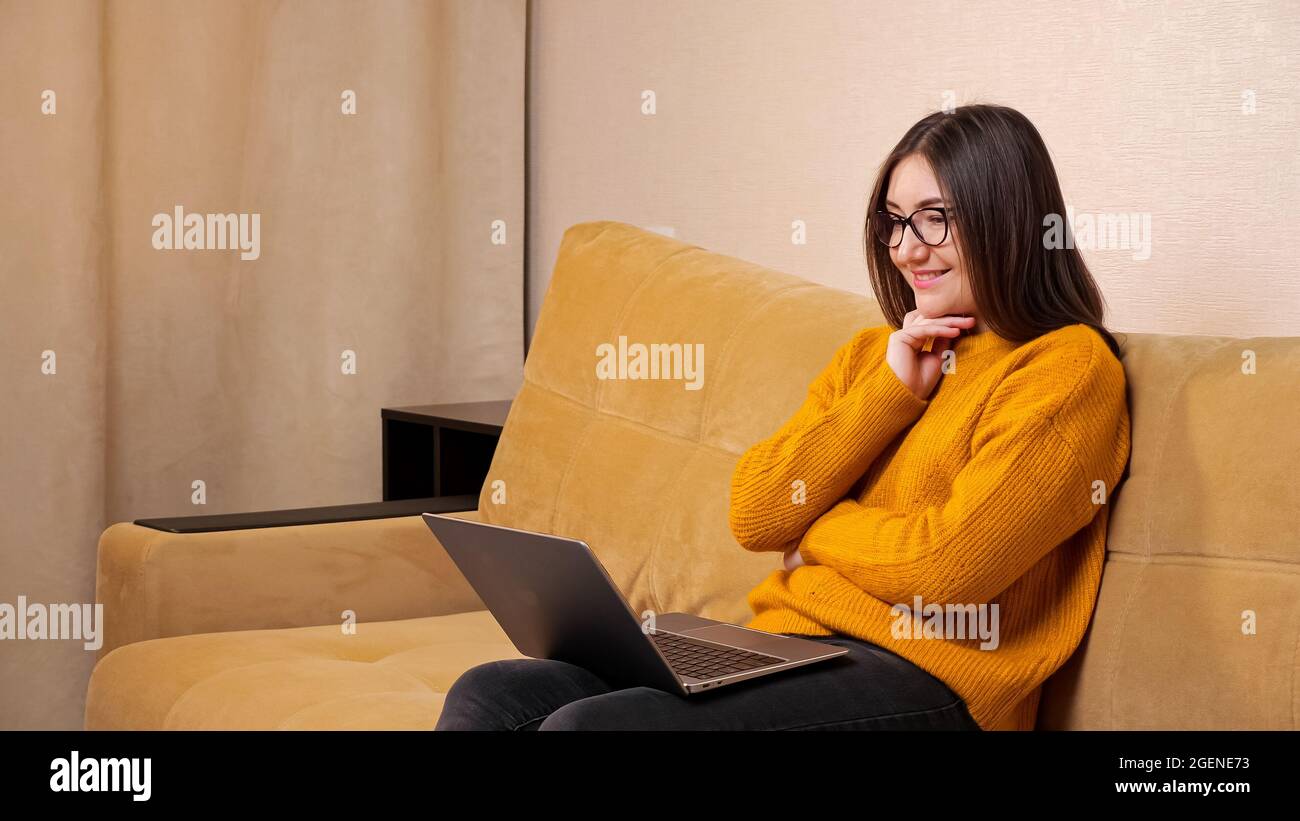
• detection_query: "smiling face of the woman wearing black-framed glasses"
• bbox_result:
[885,155,984,333]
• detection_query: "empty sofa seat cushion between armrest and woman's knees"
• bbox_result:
[86,611,523,730]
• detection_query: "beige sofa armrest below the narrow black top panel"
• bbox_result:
[95,504,484,657]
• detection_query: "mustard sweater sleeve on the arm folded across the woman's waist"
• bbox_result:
[796,329,1128,604]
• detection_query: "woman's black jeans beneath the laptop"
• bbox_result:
[434,634,980,730]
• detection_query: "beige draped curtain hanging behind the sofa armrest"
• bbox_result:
[0,0,525,729]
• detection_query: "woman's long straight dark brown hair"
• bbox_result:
[863,104,1123,359]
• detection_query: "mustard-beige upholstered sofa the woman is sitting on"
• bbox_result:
[86,221,1300,729]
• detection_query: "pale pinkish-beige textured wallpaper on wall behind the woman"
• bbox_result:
[528,0,1300,345]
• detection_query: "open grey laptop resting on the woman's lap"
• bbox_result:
[424,513,849,695]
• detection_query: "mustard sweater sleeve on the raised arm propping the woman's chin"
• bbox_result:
[728,326,930,551]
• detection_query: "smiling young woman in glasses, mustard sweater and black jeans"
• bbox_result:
[438,105,1128,730]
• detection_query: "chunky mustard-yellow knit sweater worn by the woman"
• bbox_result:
[729,325,1128,730]
